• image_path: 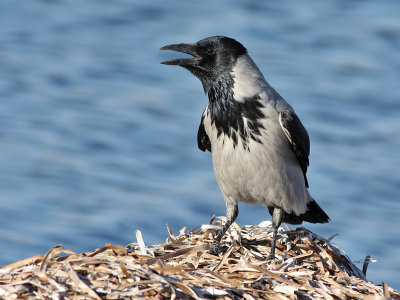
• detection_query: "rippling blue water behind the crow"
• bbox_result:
[0,0,400,289]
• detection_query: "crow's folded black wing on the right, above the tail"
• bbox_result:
[279,110,310,187]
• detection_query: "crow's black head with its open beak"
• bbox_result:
[160,36,247,90]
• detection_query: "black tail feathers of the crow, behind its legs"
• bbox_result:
[268,199,330,225]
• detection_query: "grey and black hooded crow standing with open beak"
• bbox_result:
[160,36,329,259]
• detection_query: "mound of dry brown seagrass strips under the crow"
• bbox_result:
[0,220,400,299]
